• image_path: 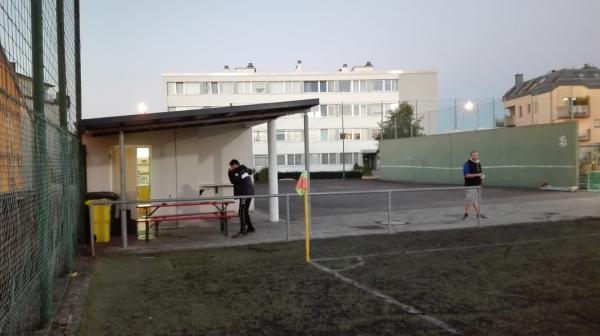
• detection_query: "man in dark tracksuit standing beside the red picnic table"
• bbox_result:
[228,159,254,238]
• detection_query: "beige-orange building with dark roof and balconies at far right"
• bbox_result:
[503,65,600,173]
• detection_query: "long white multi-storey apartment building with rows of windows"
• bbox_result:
[162,61,437,171]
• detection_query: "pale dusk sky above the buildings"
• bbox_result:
[81,0,600,118]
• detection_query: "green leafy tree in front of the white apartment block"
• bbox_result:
[379,103,423,139]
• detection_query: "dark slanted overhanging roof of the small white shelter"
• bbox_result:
[79,99,319,136]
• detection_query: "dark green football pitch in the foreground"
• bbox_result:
[79,220,600,335]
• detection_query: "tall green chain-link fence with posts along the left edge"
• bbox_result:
[0,0,83,336]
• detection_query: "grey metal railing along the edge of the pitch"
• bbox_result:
[88,186,481,256]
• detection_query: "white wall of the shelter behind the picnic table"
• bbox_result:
[83,125,252,217]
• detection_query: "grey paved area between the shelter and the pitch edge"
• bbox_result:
[103,180,600,254]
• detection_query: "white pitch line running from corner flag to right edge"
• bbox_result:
[313,233,600,261]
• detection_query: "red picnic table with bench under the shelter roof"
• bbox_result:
[137,201,237,242]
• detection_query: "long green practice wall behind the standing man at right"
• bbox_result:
[380,122,579,187]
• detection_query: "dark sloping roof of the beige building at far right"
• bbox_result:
[502,65,600,101]
